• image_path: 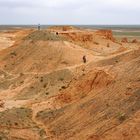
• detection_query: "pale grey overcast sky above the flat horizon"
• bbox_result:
[0,0,140,24]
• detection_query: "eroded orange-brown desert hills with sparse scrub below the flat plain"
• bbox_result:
[0,26,140,140]
